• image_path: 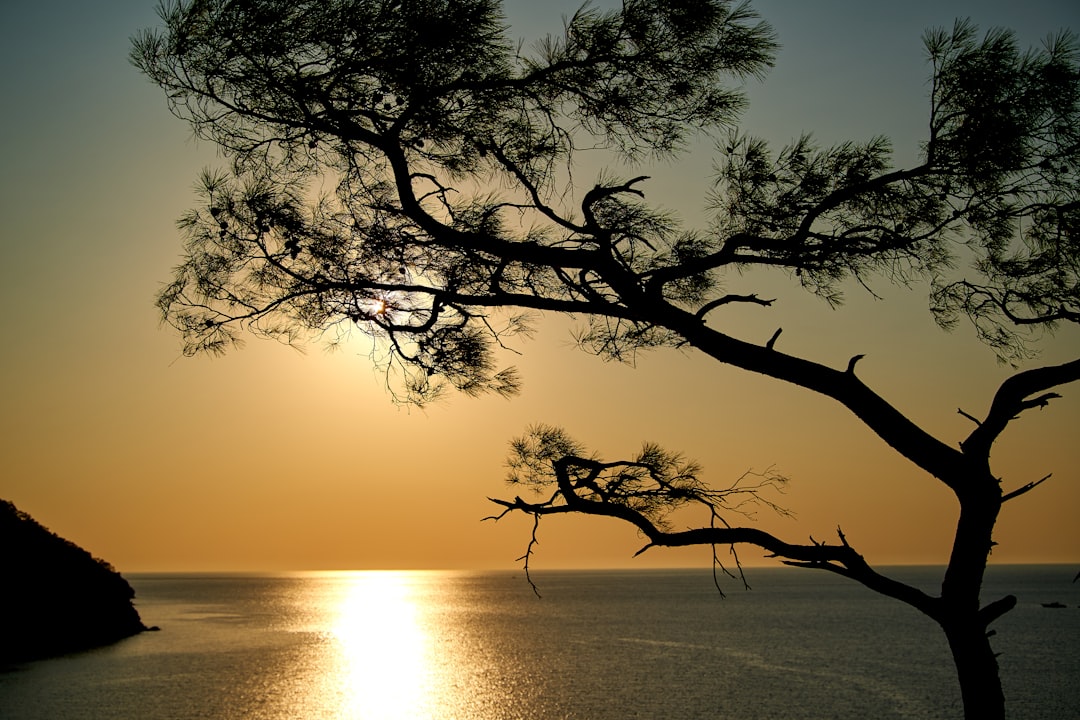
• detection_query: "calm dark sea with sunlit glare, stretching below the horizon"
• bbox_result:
[0,566,1080,720]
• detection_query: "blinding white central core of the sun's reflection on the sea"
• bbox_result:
[323,571,437,720]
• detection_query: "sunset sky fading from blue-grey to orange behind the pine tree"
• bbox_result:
[0,0,1080,571]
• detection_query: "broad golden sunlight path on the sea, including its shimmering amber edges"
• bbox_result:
[282,570,527,720]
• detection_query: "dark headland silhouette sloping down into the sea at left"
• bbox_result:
[0,500,157,663]
